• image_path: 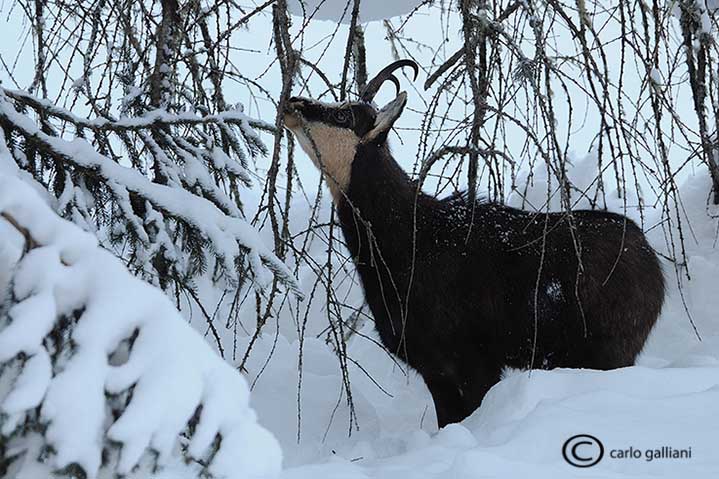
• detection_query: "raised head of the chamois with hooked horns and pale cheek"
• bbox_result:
[285,60,419,201]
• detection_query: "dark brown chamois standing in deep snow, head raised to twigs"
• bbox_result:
[285,60,664,427]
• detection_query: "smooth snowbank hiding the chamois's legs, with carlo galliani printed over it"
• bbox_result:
[300,367,719,478]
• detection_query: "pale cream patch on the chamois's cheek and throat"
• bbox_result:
[285,120,360,204]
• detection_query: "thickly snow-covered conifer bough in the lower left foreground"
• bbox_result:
[0,172,281,478]
